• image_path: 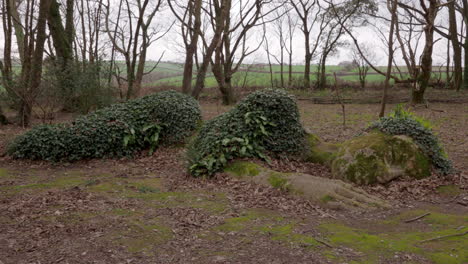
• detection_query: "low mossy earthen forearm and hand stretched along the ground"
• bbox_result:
[224,161,388,210]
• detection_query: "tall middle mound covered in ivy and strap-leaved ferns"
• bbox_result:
[188,89,306,176]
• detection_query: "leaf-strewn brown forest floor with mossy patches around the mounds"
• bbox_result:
[0,100,468,264]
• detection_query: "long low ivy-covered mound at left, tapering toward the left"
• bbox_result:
[7,91,201,161]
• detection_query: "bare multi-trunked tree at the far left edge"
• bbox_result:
[0,0,51,127]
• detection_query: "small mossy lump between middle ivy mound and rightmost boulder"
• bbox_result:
[306,134,339,166]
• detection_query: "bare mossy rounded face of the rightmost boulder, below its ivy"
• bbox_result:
[332,131,431,185]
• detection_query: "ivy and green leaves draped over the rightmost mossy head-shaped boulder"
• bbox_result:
[370,105,453,174]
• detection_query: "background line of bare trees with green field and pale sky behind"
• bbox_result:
[0,0,468,126]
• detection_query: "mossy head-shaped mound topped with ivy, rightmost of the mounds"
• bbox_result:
[332,106,452,184]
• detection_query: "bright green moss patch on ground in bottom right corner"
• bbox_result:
[319,212,468,264]
